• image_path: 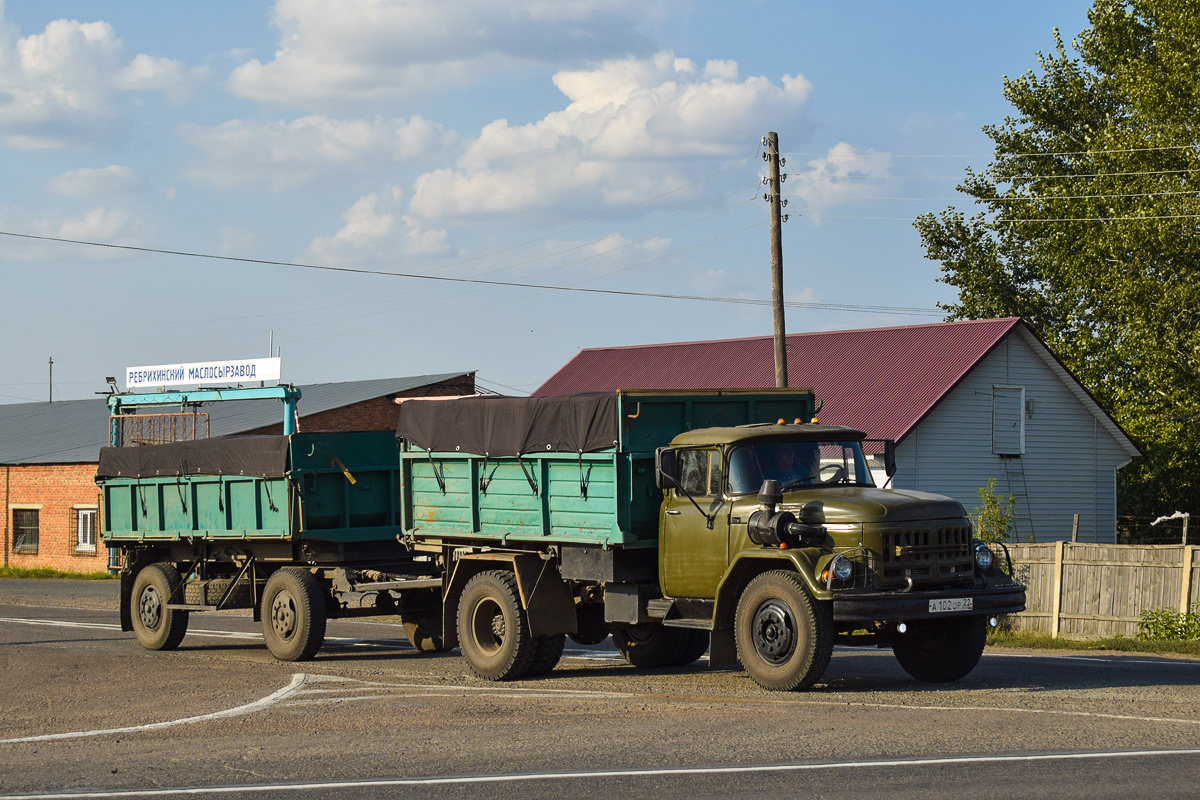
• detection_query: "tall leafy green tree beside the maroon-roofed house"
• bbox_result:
[916,0,1200,527]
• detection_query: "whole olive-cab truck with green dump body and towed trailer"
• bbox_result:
[96,387,1025,691]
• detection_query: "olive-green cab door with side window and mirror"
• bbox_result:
[659,447,730,597]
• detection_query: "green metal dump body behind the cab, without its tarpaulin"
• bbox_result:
[400,389,814,548]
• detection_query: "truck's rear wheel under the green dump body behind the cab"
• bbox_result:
[458,570,538,680]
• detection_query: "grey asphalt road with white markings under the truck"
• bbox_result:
[0,581,1200,800]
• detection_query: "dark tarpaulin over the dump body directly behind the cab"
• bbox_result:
[396,392,617,457]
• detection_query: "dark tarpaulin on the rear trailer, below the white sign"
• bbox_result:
[96,437,288,479]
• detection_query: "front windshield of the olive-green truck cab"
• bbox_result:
[730,441,875,494]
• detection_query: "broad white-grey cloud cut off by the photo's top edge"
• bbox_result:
[229,0,665,108]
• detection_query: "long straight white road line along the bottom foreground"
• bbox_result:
[0,750,1200,800]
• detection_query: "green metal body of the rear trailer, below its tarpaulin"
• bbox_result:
[96,431,402,545]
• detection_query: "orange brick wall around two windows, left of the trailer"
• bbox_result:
[0,464,108,572]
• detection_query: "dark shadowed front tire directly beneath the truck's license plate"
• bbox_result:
[892,616,988,684]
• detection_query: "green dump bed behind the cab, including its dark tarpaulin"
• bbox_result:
[396,389,812,547]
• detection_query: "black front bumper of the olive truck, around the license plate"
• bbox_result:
[833,584,1025,622]
